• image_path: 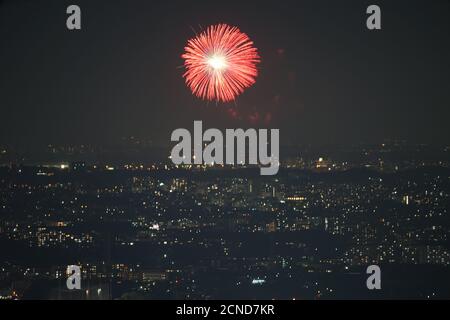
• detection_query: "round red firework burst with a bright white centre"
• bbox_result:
[181,24,260,102]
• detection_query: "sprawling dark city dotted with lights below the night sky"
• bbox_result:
[0,146,450,299]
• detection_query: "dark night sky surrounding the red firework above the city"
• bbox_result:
[0,0,450,146]
